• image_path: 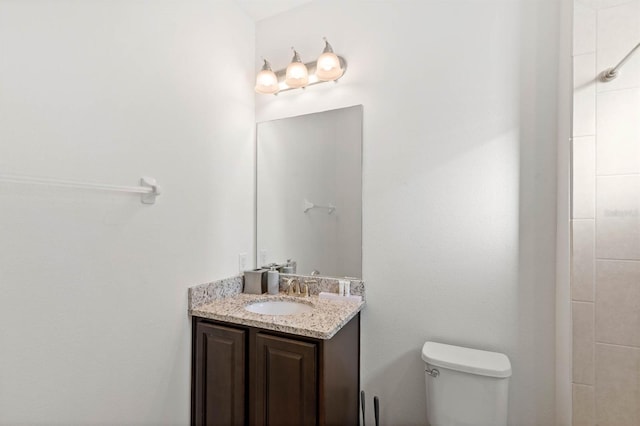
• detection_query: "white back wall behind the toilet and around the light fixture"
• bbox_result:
[255,0,559,425]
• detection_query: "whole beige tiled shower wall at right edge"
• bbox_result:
[571,0,640,426]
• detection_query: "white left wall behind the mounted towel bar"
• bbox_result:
[0,0,255,424]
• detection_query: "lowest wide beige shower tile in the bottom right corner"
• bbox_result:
[595,343,640,426]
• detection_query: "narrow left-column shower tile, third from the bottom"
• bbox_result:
[571,219,595,302]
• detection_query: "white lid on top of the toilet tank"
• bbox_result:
[422,342,511,377]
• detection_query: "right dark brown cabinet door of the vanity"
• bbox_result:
[255,333,318,426]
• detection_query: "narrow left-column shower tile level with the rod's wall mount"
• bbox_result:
[573,54,596,137]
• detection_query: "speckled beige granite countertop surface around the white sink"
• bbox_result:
[189,292,364,339]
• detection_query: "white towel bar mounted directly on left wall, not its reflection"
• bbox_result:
[0,174,161,204]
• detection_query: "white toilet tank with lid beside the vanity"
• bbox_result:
[422,342,511,426]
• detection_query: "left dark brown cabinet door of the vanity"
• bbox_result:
[192,322,246,426]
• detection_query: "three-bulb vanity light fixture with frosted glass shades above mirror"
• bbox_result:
[255,37,347,95]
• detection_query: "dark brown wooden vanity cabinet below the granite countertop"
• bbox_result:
[191,314,360,426]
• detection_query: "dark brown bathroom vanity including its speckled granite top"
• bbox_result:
[189,277,364,426]
